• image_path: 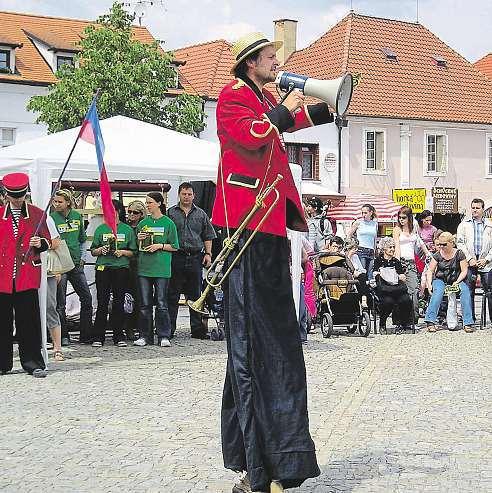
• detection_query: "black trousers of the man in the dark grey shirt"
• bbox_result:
[167,252,207,336]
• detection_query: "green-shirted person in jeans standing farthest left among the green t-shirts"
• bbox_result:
[51,189,92,346]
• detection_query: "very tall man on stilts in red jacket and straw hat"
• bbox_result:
[212,33,333,493]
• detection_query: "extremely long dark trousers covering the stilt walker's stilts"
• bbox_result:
[221,231,320,491]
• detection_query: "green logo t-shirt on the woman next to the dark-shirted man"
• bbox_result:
[137,216,179,278]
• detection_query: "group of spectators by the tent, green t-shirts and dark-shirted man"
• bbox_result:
[47,182,216,361]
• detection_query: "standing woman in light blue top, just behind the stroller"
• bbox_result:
[347,204,378,280]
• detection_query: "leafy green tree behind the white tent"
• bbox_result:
[27,2,205,134]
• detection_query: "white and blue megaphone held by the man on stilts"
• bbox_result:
[275,71,354,116]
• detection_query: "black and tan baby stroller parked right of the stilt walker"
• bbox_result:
[317,254,371,337]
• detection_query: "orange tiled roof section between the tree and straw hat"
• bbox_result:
[174,39,234,99]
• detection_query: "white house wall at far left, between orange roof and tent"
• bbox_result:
[0,83,48,144]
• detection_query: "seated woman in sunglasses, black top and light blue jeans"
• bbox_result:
[425,231,474,332]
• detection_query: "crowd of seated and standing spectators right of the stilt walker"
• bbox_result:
[301,198,492,338]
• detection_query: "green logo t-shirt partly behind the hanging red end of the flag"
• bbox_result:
[91,223,137,270]
